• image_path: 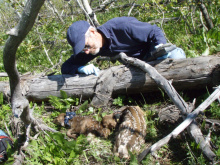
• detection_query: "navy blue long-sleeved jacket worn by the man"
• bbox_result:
[61,17,166,74]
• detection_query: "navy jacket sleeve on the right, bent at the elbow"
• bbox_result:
[127,19,167,45]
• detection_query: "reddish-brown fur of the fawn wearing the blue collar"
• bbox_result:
[54,113,116,139]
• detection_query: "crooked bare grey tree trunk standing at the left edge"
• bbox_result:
[3,0,44,120]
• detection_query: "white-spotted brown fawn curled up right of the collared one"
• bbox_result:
[114,106,146,158]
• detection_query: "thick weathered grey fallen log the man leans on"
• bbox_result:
[0,54,220,101]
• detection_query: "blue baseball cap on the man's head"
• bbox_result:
[67,21,90,55]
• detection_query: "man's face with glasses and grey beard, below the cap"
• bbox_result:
[83,32,101,55]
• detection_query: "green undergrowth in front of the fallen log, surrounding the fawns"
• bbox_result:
[0,91,220,165]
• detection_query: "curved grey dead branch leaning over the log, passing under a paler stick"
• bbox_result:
[112,53,218,161]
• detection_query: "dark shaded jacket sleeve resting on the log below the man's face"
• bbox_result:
[61,53,97,75]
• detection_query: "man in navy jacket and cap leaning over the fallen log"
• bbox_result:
[61,17,186,75]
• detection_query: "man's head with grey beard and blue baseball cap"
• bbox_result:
[67,21,102,55]
